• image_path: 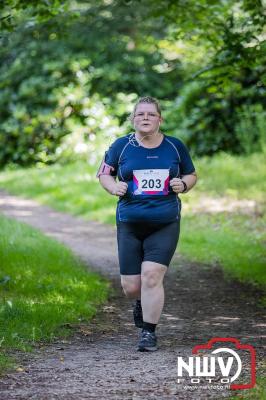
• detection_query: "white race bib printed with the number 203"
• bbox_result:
[133,169,169,195]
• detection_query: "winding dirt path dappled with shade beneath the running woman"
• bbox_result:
[0,192,266,400]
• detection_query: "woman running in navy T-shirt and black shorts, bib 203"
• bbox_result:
[97,97,197,351]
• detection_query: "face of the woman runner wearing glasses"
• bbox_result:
[133,103,162,134]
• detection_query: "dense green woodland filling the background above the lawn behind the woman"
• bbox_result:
[0,0,266,167]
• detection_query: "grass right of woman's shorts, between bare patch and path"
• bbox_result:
[178,213,266,287]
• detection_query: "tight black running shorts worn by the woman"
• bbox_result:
[117,220,180,275]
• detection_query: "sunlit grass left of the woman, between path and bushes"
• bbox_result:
[0,162,116,223]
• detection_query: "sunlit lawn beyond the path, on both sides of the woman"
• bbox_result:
[0,154,266,285]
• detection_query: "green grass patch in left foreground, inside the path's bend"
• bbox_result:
[0,217,109,367]
